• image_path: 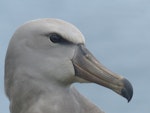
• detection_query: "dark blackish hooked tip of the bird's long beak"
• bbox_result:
[121,78,133,102]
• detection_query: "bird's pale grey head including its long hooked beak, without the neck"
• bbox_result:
[5,18,133,101]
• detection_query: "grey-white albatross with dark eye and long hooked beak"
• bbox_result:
[4,18,133,113]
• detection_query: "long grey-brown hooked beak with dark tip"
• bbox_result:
[72,44,133,102]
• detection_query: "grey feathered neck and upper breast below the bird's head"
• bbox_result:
[11,74,101,113]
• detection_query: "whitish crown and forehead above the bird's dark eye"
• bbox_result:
[22,18,85,44]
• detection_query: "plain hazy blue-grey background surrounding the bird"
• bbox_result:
[0,0,150,113]
